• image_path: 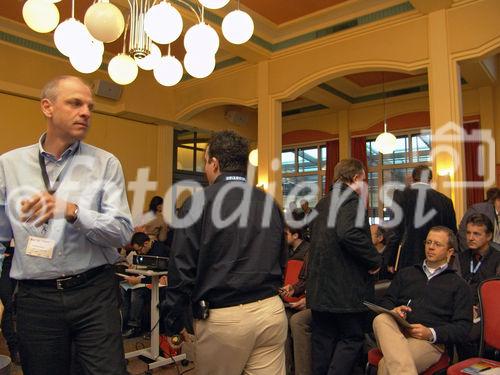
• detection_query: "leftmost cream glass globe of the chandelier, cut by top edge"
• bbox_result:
[23,0,59,33]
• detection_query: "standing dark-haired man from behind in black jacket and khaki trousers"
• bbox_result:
[162,131,287,375]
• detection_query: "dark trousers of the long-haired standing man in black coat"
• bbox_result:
[311,310,366,375]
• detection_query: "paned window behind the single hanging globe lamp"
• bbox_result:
[366,132,431,224]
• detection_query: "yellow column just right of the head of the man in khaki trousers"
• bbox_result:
[257,61,283,203]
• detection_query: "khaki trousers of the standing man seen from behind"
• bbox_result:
[194,296,288,375]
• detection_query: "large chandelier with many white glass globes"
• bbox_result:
[23,0,254,86]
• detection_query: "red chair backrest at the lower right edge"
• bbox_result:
[478,277,500,356]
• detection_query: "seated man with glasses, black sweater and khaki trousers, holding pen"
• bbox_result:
[373,226,472,375]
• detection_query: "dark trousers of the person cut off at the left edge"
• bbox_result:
[0,255,19,356]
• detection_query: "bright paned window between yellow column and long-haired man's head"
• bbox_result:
[281,145,326,207]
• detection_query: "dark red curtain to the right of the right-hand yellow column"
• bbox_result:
[464,122,484,207]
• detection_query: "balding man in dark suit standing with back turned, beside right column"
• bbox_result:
[385,165,457,272]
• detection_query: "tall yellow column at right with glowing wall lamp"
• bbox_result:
[428,9,465,221]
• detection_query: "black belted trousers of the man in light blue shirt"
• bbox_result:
[16,268,127,375]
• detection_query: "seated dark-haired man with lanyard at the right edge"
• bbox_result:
[455,214,500,360]
